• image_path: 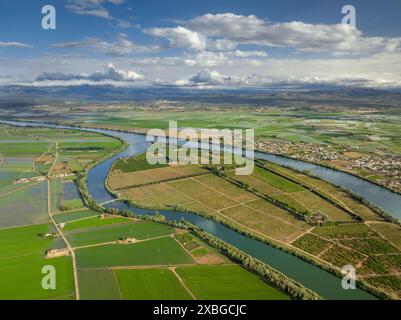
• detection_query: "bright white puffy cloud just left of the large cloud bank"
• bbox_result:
[144,26,206,50]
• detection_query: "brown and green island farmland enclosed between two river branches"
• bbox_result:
[108,151,401,297]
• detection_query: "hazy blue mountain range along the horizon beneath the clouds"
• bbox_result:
[0,85,401,107]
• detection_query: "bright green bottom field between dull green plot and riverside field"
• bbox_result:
[115,268,191,300]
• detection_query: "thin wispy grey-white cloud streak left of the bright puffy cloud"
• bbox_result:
[52,33,158,56]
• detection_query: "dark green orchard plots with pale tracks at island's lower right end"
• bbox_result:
[291,223,401,299]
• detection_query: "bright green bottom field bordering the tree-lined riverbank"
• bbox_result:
[176,265,288,300]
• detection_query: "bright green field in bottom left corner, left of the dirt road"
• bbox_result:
[0,224,74,299]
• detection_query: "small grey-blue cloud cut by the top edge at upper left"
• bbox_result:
[65,0,125,19]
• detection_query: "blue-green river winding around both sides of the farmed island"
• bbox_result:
[0,121,401,300]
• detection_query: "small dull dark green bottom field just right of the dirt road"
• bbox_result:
[78,269,121,300]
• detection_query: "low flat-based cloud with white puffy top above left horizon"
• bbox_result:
[36,64,144,82]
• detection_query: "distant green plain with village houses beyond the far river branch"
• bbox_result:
[68,106,401,192]
